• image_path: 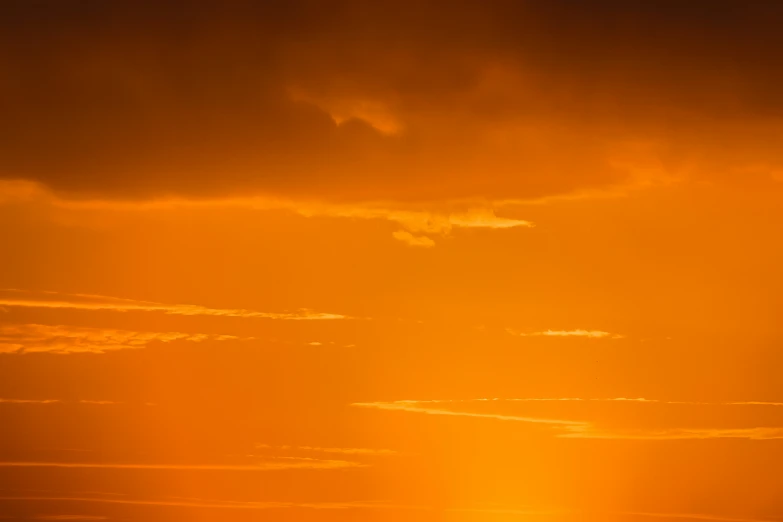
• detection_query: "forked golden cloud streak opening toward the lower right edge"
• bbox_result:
[352,398,783,440]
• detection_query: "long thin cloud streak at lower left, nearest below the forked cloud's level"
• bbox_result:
[0,457,366,471]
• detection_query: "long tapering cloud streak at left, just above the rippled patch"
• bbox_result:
[0,289,347,321]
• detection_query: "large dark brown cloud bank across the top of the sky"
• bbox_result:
[0,0,783,201]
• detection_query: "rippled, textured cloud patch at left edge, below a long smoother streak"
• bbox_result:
[0,324,243,354]
